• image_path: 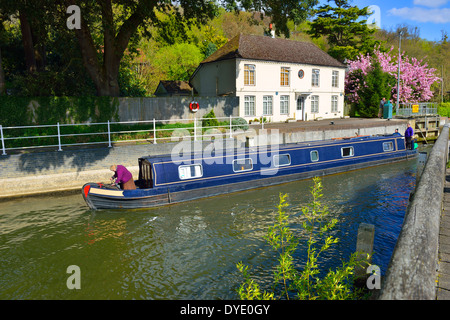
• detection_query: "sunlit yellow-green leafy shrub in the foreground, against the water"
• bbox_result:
[237,177,368,300]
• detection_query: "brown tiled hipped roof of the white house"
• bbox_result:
[201,34,345,68]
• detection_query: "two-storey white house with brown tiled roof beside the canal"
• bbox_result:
[190,34,346,122]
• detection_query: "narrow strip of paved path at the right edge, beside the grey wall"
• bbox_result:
[436,169,450,300]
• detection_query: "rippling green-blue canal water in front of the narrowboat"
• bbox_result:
[0,160,417,300]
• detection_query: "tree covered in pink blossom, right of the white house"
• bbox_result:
[345,47,441,103]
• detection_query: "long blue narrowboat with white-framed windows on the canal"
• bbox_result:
[81,134,417,209]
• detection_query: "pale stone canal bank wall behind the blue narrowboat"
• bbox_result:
[0,119,408,199]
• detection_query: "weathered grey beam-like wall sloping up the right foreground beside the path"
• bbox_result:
[380,125,449,300]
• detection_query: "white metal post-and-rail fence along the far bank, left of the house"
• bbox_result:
[0,116,248,155]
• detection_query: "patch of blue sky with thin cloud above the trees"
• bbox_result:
[320,0,450,41]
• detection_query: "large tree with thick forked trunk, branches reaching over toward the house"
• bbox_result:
[65,0,317,96]
